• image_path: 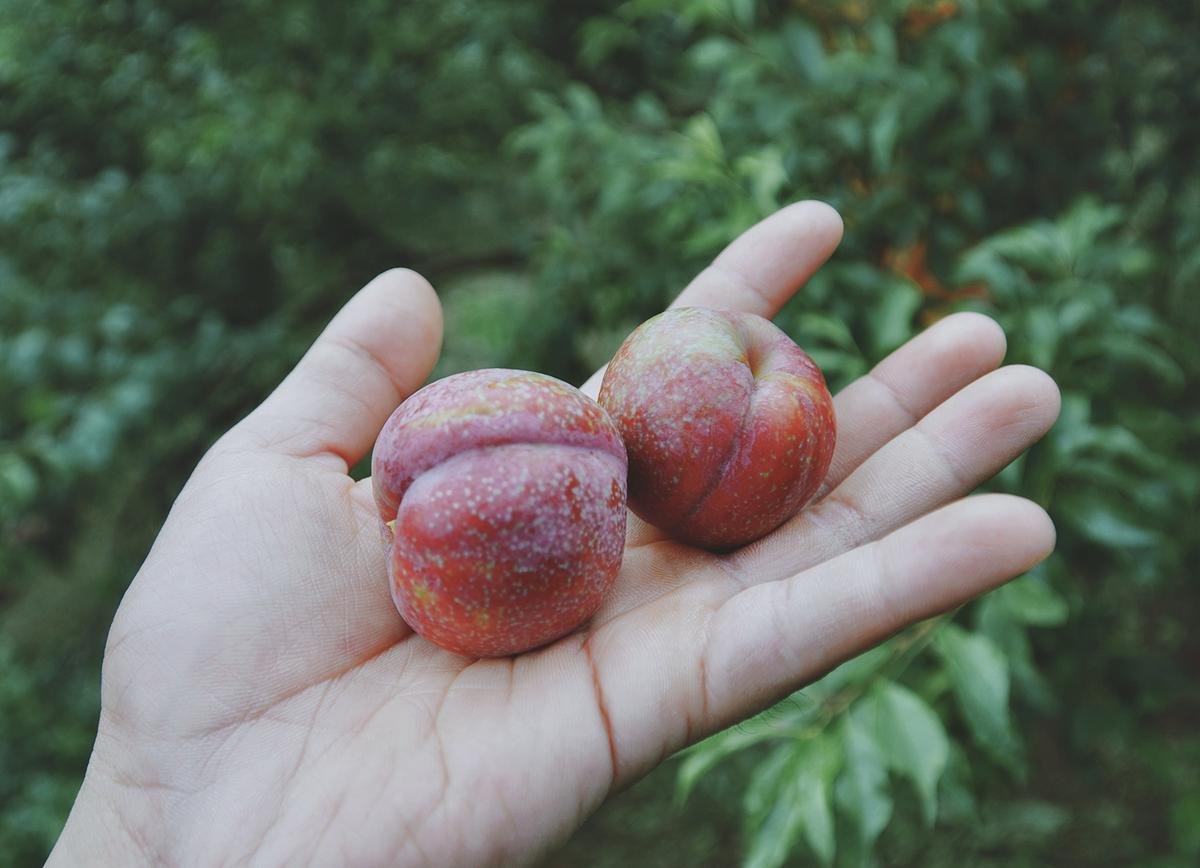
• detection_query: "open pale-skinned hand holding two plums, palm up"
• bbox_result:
[52,202,1058,866]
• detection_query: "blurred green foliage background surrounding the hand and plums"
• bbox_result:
[0,0,1200,868]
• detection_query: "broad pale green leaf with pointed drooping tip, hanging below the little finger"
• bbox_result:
[860,683,949,825]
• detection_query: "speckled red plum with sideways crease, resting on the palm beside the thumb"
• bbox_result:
[371,370,628,657]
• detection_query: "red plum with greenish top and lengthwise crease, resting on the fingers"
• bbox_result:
[600,307,836,551]
